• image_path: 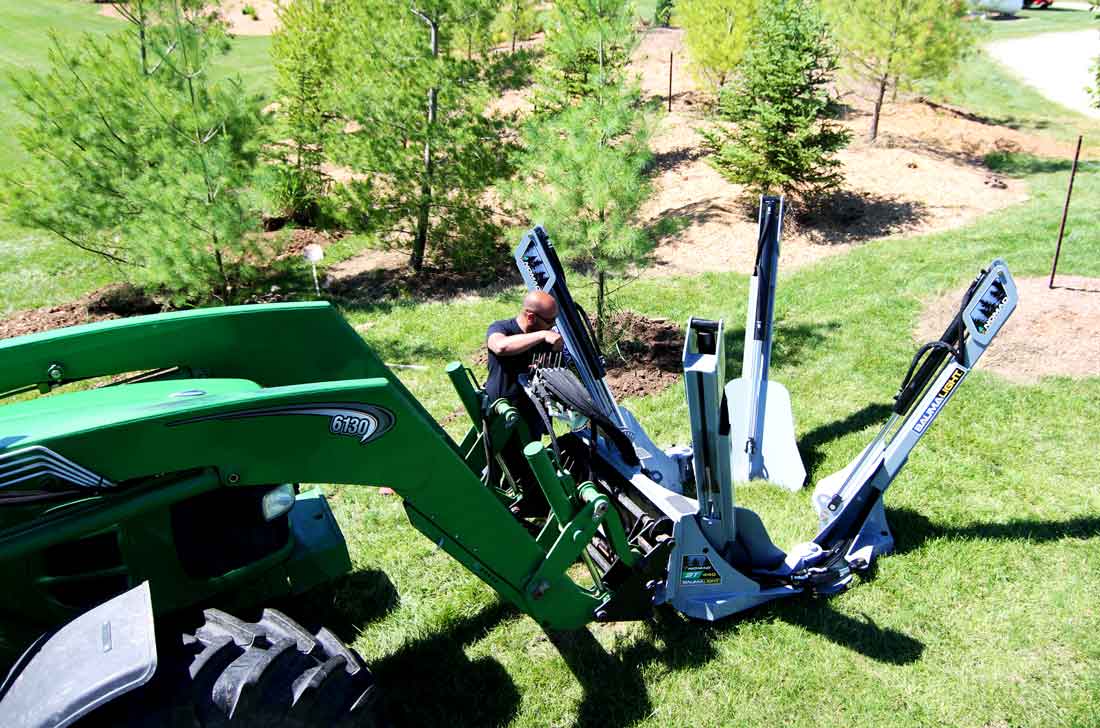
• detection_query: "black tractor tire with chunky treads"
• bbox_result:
[77,609,387,728]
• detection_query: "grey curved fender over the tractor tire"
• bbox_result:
[0,582,156,728]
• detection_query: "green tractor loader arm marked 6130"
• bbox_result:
[0,304,630,629]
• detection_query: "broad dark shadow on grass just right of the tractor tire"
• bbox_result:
[371,602,520,728]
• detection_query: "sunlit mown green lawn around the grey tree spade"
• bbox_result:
[293,159,1100,728]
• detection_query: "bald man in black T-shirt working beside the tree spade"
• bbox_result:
[485,290,562,437]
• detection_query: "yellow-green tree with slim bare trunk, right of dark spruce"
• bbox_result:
[822,0,976,141]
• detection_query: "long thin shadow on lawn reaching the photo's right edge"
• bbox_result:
[887,507,1100,554]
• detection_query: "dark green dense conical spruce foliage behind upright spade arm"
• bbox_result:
[704,0,850,197]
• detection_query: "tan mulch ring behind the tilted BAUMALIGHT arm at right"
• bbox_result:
[916,275,1100,384]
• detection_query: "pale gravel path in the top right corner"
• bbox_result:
[986,29,1100,119]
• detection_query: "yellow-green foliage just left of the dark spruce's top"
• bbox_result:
[677,0,759,93]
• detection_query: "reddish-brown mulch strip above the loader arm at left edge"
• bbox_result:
[0,284,163,339]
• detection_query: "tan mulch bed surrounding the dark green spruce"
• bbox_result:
[633,29,1034,275]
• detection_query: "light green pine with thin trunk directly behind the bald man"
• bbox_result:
[513,0,651,344]
